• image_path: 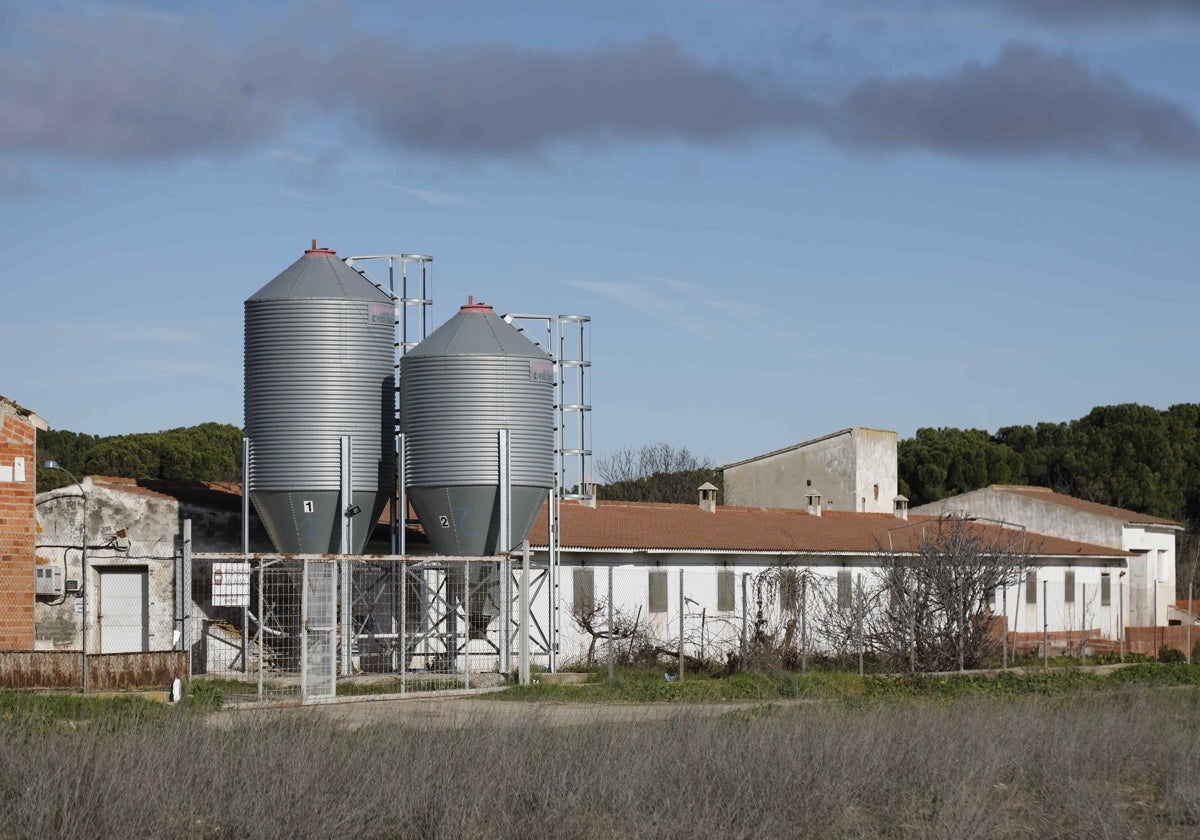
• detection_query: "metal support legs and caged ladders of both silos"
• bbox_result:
[241,253,592,694]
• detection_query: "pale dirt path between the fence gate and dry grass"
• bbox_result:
[209,697,793,730]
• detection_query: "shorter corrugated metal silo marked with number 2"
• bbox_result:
[400,302,554,556]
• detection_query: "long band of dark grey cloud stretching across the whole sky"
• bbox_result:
[0,7,1200,169]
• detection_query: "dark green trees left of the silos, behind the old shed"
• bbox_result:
[37,422,242,493]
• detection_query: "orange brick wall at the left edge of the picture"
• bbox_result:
[0,404,37,650]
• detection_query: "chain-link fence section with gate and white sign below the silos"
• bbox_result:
[185,554,548,700]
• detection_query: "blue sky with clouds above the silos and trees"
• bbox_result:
[0,0,1200,462]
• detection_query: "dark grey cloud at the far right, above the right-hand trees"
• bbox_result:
[829,43,1200,162]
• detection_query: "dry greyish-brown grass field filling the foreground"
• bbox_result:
[0,686,1200,840]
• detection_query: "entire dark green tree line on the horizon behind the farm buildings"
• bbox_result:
[37,403,1200,529]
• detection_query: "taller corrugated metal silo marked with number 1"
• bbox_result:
[245,240,395,553]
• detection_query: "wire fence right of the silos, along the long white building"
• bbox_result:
[562,565,1185,672]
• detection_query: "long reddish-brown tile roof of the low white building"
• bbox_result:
[529,502,1129,557]
